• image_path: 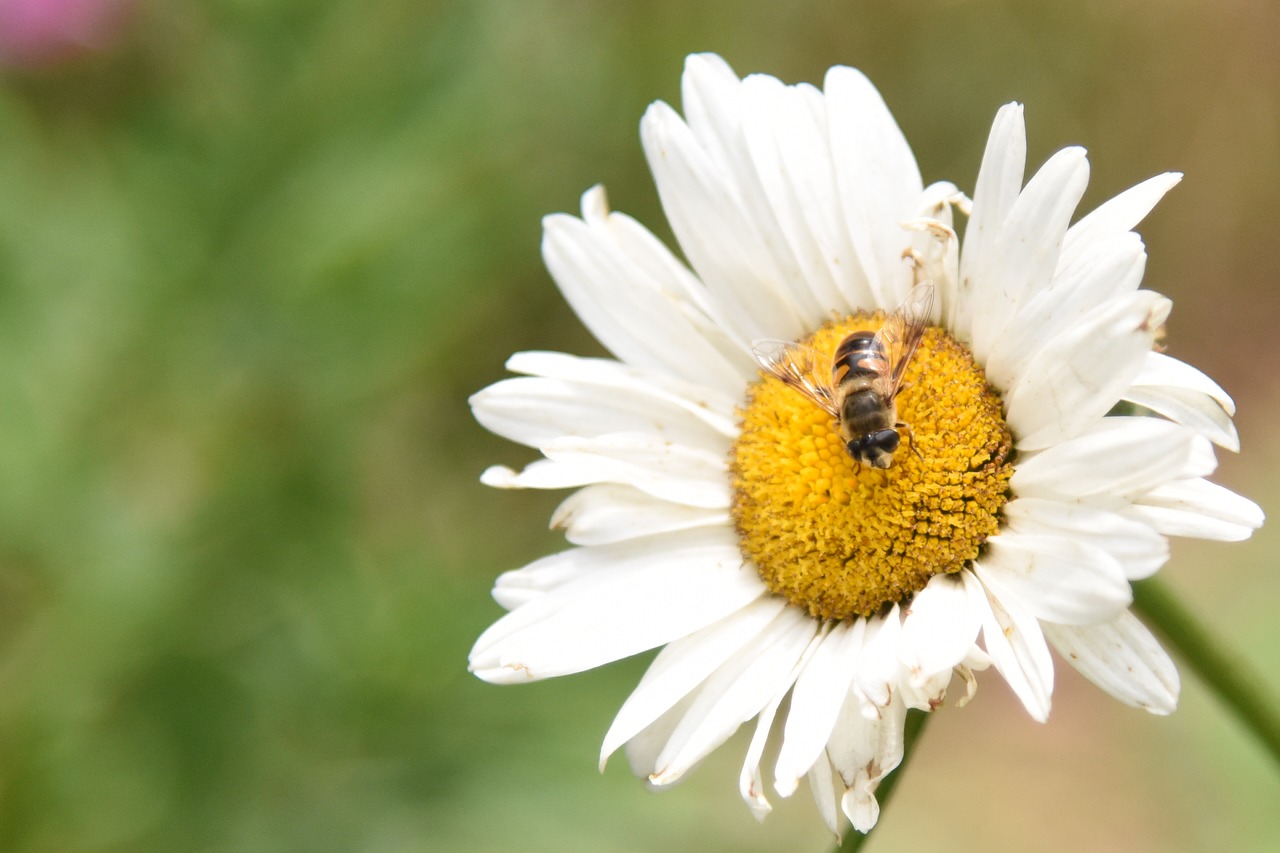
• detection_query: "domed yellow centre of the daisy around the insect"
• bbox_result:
[731,314,1012,620]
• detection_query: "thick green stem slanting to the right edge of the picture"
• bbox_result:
[1133,578,1280,763]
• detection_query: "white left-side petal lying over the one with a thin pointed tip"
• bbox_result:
[543,433,730,508]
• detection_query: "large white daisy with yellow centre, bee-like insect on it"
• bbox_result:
[471,55,1262,834]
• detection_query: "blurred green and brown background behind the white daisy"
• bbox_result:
[0,0,1280,853]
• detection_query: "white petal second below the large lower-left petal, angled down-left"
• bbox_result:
[649,607,818,785]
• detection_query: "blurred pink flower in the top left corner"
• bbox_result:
[0,0,132,67]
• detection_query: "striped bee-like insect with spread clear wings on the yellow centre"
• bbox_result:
[751,282,933,469]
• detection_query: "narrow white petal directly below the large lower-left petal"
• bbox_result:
[600,596,786,770]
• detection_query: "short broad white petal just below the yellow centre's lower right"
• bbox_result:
[899,575,982,688]
